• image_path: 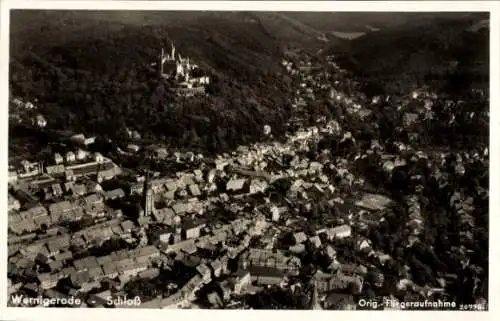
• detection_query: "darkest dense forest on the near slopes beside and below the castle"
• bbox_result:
[10,19,296,150]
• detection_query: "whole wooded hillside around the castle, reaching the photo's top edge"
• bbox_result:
[10,11,334,150]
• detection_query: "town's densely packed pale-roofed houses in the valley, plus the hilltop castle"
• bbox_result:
[8,38,488,309]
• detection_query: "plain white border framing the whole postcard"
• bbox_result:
[0,0,500,321]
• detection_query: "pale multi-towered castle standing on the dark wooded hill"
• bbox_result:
[158,44,210,96]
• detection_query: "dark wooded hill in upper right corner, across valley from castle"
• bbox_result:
[331,14,489,94]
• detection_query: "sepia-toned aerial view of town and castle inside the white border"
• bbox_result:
[2,9,490,311]
